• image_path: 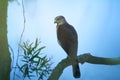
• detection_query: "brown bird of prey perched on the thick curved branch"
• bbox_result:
[54,15,81,78]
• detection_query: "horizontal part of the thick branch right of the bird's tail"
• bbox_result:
[78,53,120,65]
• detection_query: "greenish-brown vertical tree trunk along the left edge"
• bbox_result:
[0,0,11,80]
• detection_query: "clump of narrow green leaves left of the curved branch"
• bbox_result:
[18,39,52,80]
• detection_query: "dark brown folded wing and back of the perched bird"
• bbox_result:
[57,25,77,55]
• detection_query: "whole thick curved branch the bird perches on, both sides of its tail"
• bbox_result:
[48,53,120,80]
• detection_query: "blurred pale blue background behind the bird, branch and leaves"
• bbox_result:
[7,0,120,80]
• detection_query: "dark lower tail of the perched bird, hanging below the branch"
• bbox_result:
[72,62,81,78]
